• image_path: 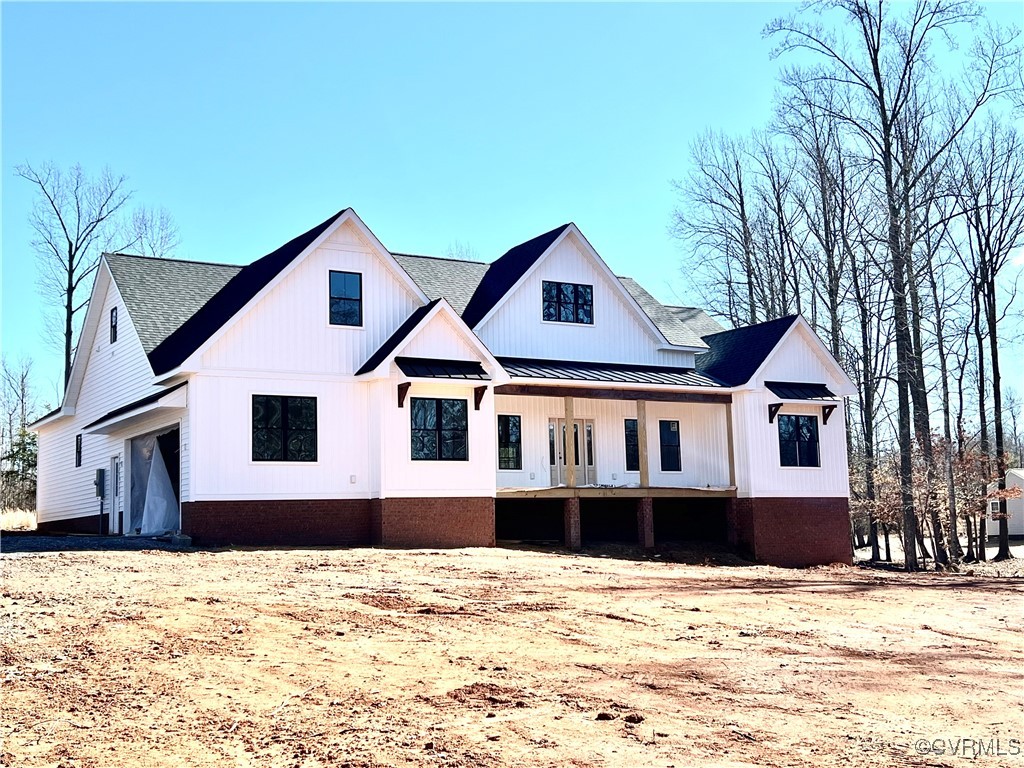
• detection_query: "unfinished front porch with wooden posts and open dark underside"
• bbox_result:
[495,382,736,549]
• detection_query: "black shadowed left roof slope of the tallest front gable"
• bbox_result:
[150,208,348,376]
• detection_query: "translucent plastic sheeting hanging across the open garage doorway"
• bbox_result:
[130,427,178,536]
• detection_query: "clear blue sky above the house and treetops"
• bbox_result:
[2,2,1021,402]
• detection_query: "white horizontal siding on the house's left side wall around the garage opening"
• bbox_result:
[36,264,181,522]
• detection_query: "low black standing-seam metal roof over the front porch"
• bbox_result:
[496,357,722,387]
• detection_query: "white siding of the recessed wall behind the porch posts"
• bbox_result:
[495,394,729,487]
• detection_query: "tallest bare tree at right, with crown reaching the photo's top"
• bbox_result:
[766,0,1017,570]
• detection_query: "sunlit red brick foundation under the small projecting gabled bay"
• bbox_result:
[369,497,495,547]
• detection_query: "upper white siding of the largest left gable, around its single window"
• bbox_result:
[202,222,420,376]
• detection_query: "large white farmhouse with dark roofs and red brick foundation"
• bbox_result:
[29,209,855,565]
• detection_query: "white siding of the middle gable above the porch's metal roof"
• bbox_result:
[475,233,693,368]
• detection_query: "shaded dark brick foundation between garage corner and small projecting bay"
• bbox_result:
[181,499,371,546]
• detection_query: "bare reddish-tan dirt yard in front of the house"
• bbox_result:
[0,549,1024,768]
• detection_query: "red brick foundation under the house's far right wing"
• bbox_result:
[728,498,853,568]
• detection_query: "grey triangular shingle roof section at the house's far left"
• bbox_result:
[103,253,242,354]
